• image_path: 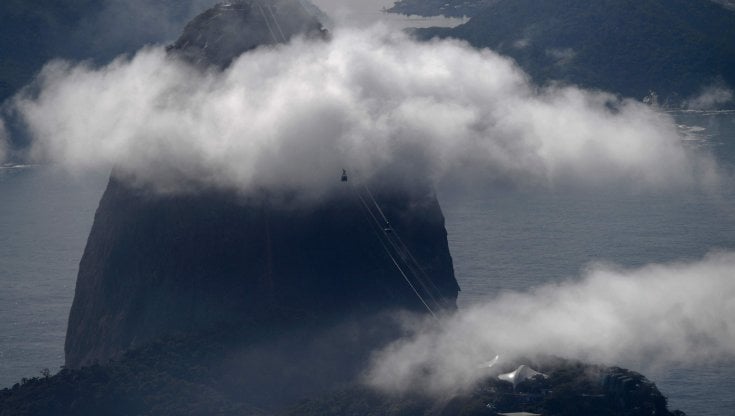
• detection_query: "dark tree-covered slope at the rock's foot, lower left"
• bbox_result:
[0,330,261,416]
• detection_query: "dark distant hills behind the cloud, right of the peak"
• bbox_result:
[417,0,735,104]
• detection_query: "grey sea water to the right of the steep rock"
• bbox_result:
[440,111,735,416]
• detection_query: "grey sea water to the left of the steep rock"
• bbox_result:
[0,166,106,387]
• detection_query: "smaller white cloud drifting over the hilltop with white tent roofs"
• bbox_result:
[365,252,735,393]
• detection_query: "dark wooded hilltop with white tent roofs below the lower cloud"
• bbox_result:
[289,359,683,416]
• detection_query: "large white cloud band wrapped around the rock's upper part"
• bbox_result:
[4,26,716,198]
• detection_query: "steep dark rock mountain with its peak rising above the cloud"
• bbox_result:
[65,0,459,368]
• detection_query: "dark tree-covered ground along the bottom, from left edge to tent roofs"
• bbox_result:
[0,329,683,416]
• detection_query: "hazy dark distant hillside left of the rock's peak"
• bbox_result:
[0,0,216,102]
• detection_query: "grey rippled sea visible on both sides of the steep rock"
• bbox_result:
[0,113,735,416]
